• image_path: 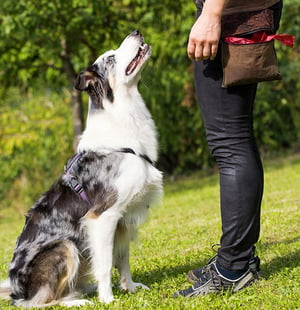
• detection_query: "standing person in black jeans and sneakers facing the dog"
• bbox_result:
[174,0,282,297]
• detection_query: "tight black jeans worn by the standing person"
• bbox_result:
[195,2,282,270]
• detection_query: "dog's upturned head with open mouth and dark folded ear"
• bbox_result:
[75,30,151,108]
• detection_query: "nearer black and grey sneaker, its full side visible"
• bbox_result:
[173,259,258,297]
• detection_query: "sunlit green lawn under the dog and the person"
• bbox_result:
[0,154,300,310]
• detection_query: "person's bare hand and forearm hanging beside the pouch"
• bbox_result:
[187,0,228,61]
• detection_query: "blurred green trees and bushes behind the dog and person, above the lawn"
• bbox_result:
[0,0,300,212]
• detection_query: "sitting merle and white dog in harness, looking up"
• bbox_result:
[2,31,162,308]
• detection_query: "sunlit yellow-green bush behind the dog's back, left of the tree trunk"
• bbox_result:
[0,88,73,209]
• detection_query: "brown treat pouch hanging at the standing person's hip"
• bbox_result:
[221,9,281,88]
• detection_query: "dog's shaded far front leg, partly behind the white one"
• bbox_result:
[114,223,149,293]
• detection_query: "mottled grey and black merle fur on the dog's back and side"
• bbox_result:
[9,152,124,299]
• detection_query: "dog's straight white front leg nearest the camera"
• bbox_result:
[84,207,121,303]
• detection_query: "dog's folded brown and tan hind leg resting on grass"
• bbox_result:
[11,240,79,308]
